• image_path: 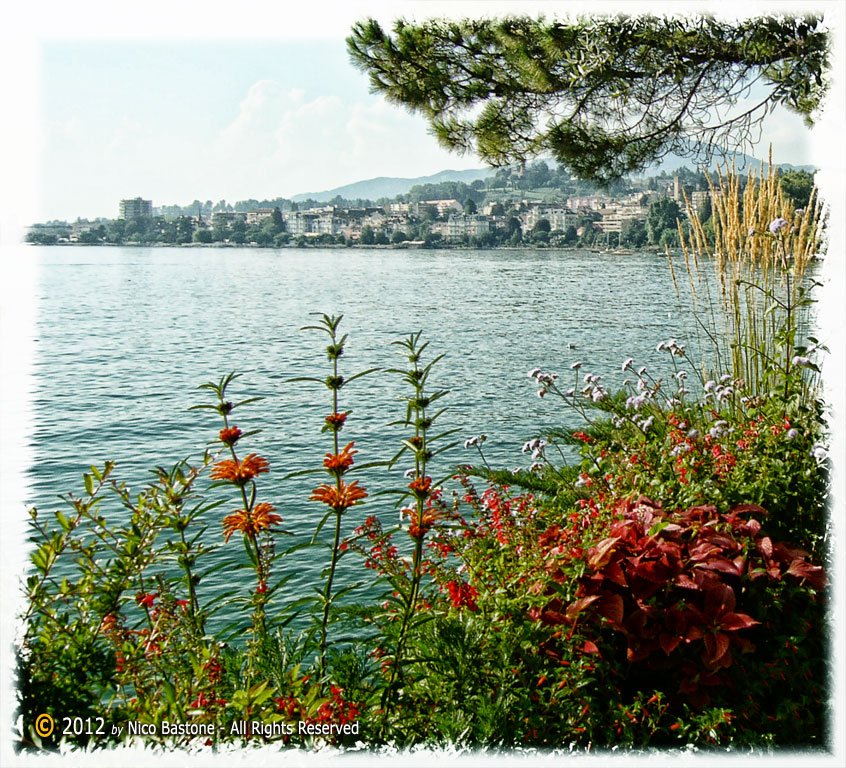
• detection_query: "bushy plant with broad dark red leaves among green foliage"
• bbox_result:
[536,497,826,707]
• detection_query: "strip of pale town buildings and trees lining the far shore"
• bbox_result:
[28,169,732,245]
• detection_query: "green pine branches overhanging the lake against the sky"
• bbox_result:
[347,16,829,181]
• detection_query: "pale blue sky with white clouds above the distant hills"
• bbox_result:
[0,0,836,221]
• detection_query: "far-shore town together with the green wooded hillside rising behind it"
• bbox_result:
[26,161,813,248]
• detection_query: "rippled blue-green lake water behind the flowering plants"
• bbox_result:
[26,247,704,632]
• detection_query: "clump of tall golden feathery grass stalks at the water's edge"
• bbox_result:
[670,152,822,402]
